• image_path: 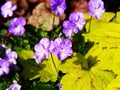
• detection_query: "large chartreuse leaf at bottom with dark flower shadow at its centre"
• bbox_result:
[60,53,115,90]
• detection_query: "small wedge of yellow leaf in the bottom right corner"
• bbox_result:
[106,75,120,90]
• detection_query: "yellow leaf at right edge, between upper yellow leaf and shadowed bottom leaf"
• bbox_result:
[85,44,120,74]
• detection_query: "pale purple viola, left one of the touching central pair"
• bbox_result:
[34,38,50,64]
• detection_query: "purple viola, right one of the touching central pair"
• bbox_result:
[52,38,72,61]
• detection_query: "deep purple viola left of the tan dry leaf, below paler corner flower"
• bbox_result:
[8,17,26,36]
